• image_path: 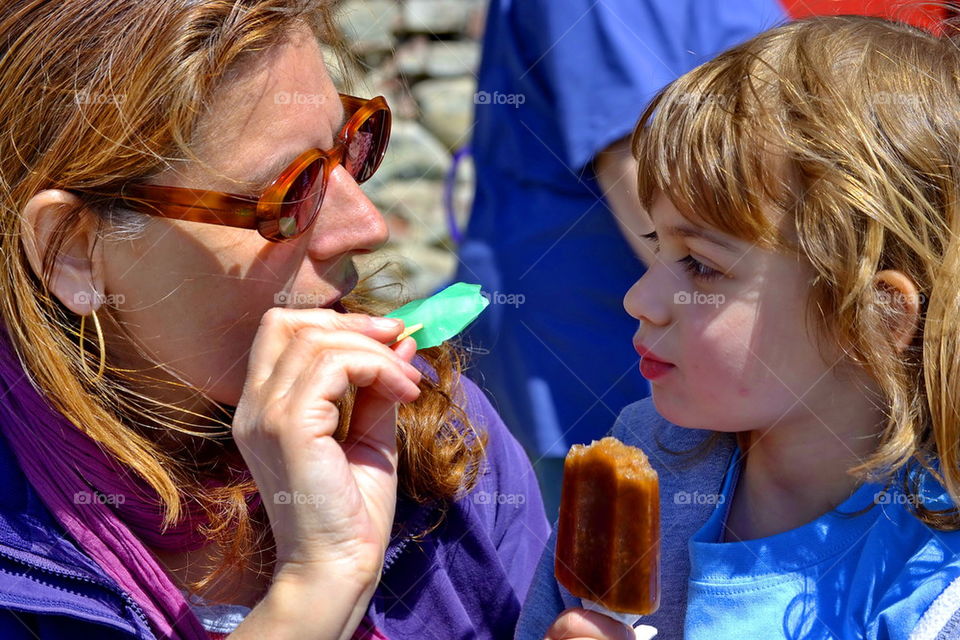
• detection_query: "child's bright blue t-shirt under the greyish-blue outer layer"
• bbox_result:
[684,451,960,640]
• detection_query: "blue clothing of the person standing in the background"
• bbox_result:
[456,0,786,458]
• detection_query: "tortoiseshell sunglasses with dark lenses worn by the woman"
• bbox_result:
[106,94,391,242]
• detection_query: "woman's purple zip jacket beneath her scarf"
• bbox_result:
[0,378,550,640]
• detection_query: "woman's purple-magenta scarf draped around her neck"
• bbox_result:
[0,328,233,640]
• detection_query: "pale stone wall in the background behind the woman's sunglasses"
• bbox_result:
[339,0,486,297]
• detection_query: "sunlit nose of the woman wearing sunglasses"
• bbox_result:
[308,166,390,261]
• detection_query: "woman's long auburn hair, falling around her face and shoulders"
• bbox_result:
[0,0,486,591]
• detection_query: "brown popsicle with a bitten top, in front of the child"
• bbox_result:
[554,437,660,615]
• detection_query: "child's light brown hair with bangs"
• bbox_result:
[633,16,960,529]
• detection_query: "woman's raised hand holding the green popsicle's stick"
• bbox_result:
[233,308,420,633]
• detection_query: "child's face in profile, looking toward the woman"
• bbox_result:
[624,193,847,432]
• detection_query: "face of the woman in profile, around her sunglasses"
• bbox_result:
[101,31,388,405]
